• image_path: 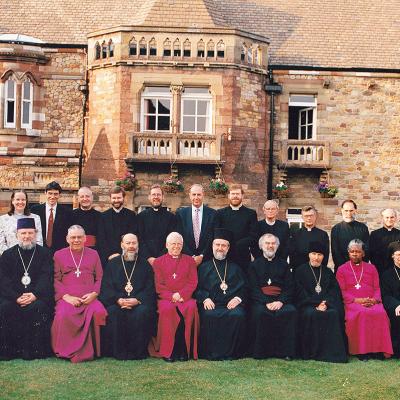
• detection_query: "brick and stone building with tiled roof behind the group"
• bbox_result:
[0,0,400,233]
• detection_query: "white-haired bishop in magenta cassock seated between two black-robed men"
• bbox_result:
[149,232,199,362]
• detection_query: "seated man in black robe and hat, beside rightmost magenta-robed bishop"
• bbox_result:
[295,242,347,362]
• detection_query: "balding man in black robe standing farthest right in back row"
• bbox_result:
[369,208,400,277]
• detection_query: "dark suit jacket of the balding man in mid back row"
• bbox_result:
[176,206,215,261]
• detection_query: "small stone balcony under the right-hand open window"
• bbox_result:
[281,140,330,169]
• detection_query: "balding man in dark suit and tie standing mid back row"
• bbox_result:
[176,184,215,266]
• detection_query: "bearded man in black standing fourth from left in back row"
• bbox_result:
[97,186,137,266]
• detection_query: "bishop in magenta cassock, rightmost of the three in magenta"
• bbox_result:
[336,239,393,361]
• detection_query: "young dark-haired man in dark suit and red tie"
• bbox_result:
[32,181,72,252]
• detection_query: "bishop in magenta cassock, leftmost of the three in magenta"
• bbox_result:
[51,225,107,363]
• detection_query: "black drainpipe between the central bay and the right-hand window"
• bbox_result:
[264,69,282,199]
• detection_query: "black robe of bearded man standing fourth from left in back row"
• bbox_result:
[97,207,137,266]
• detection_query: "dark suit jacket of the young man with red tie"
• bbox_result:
[31,203,72,252]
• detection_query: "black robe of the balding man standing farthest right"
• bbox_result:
[369,227,400,276]
